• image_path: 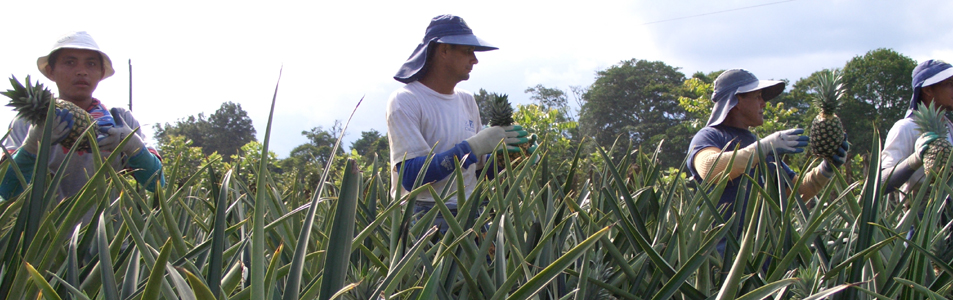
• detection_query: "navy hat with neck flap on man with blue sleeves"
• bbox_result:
[394,15,499,83]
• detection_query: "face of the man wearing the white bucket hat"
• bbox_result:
[47,48,103,103]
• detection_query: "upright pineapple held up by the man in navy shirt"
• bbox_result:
[810,70,845,158]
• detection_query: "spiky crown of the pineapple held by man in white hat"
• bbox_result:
[0,75,53,124]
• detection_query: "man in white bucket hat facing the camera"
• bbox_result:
[0,31,165,199]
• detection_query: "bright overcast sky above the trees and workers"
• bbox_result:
[0,0,953,157]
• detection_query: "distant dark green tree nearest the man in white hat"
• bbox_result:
[155,102,255,161]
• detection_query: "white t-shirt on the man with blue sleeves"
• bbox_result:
[387,81,480,203]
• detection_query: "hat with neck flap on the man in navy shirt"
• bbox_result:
[705,69,784,126]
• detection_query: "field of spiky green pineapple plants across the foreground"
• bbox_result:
[0,77,953,300]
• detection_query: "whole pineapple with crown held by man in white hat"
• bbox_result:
[0,75,98,151]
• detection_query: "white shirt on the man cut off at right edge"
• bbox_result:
[880,117,953,200]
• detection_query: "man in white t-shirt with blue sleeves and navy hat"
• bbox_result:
[387,15,528,232]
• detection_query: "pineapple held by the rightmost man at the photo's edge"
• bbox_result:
[913,102,953,175]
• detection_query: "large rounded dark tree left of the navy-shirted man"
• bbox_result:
[579,59,688,166]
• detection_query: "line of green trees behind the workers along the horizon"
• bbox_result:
[155,49,917,190]
